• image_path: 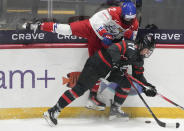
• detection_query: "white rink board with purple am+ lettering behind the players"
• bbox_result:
[0,48,184,108]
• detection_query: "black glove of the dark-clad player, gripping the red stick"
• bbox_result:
[142,83,157,97]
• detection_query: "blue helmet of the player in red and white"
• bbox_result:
[121,1,136,24]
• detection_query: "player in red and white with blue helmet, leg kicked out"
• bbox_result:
[23,2,139,110]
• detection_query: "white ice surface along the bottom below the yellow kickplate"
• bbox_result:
[0,118,184,131]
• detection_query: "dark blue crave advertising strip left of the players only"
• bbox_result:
[0,30,87,44]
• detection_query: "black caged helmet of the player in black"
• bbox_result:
[138,34,155,57]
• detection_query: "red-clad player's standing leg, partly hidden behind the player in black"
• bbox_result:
[71,20,105,110]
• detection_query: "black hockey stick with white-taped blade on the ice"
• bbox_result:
[126,73,180,128]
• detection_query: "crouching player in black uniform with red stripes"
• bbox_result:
[43,35,157,126]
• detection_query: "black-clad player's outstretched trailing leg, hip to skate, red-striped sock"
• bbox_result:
[44,55,110,126]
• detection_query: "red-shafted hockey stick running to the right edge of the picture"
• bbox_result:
[128,75,184,110]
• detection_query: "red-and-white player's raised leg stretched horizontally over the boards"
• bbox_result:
[22,19,91,38]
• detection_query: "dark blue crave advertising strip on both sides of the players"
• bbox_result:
[0,29,184,44]
